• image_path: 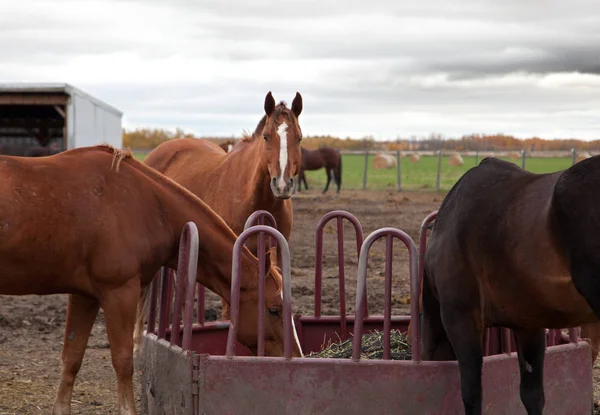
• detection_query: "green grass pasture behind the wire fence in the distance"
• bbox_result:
[135,153,571,191]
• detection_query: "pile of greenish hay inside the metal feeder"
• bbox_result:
[305,330,412,360]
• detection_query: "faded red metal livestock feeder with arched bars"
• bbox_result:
[142,211,593,415]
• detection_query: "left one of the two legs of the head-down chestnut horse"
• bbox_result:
[52,294,100,415]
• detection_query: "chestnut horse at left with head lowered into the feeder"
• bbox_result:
[0,146,301,415]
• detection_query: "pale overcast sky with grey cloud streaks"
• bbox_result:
[0,0,600,139]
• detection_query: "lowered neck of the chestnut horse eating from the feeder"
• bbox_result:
[138,158,258,303]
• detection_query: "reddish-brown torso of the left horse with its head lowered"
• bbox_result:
[0,148,173,295]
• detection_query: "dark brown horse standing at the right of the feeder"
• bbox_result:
[422,156,600,414]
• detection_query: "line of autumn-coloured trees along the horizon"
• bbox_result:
[123,128,600,152]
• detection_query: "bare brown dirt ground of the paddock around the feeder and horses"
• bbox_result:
[0,189,600,415]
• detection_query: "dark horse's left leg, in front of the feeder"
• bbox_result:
[441,303,483,415]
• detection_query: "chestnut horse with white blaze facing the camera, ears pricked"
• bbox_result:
[144,92,302,318]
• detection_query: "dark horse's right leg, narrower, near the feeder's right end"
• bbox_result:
[513,329,546,415]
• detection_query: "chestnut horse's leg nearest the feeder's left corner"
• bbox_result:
[102,278,140,415]
